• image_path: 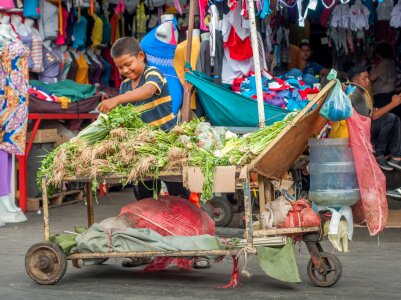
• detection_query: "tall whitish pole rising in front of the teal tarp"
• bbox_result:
[247,0,265,127]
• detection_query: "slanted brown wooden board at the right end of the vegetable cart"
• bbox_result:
[250,81,335,180]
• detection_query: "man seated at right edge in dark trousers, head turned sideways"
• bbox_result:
[348,65,401,171]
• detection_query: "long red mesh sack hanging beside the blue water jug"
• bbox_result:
[347,110,388,235]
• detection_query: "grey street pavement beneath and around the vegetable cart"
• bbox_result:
[0,192,401,300]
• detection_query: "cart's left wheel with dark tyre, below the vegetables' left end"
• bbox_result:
[25,242,67,284]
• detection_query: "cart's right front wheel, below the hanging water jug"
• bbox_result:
[307,252,343,287]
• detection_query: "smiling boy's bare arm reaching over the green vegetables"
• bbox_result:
[97,84,159,113]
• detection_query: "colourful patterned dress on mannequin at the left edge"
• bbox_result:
[0,40,29,155]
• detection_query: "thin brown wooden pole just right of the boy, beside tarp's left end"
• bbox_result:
[181,0,195,122]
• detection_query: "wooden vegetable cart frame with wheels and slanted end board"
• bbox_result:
[25,82,342,287]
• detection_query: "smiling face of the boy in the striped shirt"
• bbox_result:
[114,51,145,80]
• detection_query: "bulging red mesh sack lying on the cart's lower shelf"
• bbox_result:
[119,196,215,272]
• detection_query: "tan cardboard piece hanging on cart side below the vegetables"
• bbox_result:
[183,166,236,193]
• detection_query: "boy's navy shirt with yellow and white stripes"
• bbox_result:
[120,65,177,131]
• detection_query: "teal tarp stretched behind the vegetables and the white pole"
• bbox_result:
[185,71,290,127]
